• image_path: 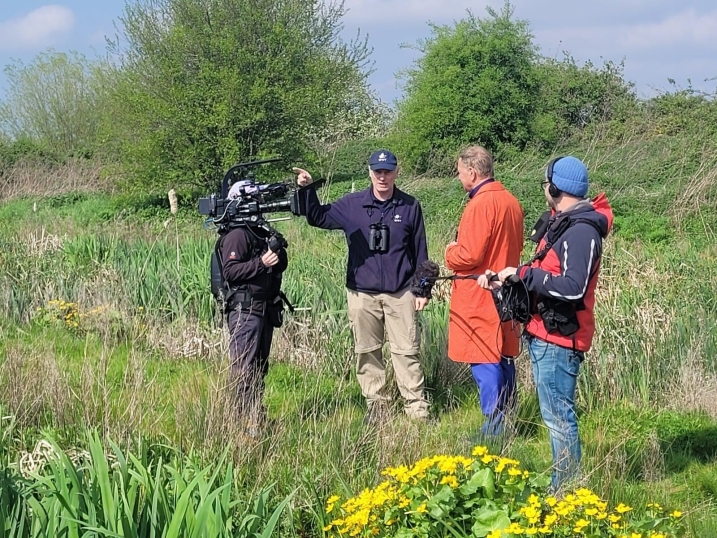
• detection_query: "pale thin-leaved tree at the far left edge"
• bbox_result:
[0,51,101,158]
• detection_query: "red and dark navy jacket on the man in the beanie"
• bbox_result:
[518,194,613,351]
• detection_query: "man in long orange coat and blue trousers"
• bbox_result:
[445,146,523,435]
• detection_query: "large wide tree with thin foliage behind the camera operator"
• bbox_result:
[107,0,369,189]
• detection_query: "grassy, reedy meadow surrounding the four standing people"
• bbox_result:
[0,126,717,536]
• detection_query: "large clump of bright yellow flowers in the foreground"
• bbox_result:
[324,446,682,538]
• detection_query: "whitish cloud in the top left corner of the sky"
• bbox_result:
[0,5,75,50]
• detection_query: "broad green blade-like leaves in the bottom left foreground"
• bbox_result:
[0,436,291,538]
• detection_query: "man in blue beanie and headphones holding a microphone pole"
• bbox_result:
[478,156,613,491]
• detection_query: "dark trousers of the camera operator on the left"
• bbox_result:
[226,308,274,420]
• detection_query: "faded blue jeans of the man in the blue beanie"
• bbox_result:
[528,336,585,490]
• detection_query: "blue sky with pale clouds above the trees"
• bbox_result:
[0,0,717,102]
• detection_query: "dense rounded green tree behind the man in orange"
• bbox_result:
[396,3,540,172]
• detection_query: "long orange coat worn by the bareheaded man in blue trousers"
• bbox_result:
[446,182,523,364]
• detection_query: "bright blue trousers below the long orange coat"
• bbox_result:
[471,357,515,435]
